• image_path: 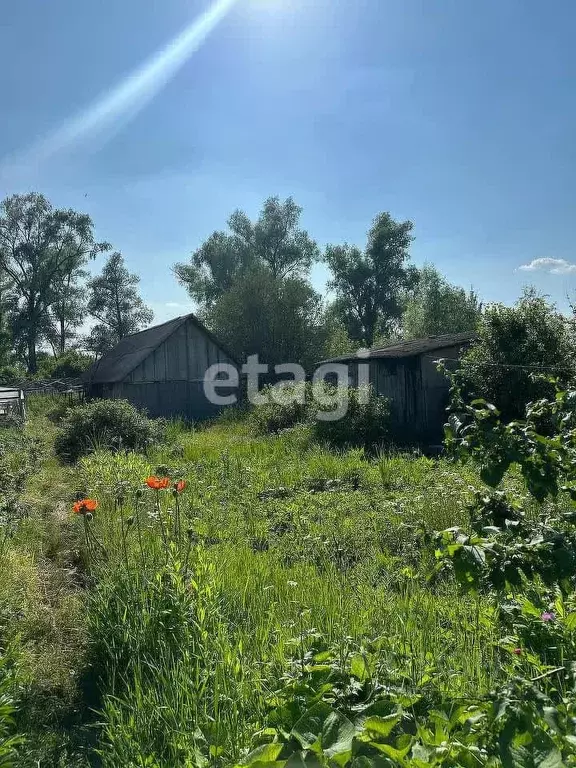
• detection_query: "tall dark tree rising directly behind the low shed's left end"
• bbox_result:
[325,213,417,346]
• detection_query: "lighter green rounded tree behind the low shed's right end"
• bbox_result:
[402,264,482,339]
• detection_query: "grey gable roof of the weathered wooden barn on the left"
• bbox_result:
[84,313,236,384]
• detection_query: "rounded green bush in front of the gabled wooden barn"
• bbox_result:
[55,400,163,463]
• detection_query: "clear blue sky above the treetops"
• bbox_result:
[0,0,576,321]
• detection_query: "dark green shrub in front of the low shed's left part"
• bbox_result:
[314,387,390,446]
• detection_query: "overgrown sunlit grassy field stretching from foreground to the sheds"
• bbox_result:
[0,400,568,768]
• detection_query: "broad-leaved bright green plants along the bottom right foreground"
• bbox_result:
[235,647,576,768]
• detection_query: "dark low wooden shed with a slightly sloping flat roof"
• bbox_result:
[323,332,475,443]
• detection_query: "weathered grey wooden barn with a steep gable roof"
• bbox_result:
[85,314,239,421]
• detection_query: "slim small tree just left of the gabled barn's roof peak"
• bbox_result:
[85,252,154,356]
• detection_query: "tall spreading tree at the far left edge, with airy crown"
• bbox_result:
[0,193,108,373]
